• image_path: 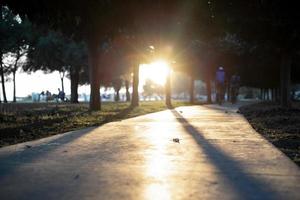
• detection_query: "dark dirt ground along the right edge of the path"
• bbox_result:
[240,102,300,166]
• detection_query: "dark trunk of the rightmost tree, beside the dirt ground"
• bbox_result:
[280,53,292,108]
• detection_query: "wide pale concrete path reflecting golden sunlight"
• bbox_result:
[0,106,300,200]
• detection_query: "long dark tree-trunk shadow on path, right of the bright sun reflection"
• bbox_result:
[170,109,278,199]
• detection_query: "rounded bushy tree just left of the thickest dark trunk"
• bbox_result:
[24,31,87,103]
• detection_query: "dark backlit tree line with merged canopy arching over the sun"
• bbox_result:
[3,0,300,110]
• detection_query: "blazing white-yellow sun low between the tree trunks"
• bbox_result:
[140,60,170,85]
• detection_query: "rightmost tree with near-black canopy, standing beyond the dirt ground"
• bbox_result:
[211,0,300,107]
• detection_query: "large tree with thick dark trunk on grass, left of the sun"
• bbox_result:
[3,0,120,110]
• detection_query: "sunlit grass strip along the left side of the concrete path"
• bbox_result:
[0,101,190,147]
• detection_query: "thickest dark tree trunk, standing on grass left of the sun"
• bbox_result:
[88,37,101,111]
